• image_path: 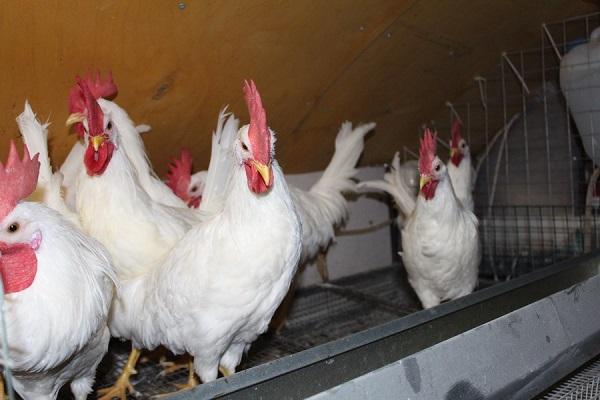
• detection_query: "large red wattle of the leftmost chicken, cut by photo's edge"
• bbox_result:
[0,242,37,294]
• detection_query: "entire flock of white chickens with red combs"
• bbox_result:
[0,74,481,400]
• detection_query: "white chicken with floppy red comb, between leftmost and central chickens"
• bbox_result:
[68,74,191,398]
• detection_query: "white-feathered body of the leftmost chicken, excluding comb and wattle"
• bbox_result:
[0,198,115,400]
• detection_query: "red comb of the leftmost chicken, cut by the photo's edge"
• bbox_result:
[0,140,40,219]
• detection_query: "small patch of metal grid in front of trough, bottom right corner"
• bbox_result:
[539,358,600,400]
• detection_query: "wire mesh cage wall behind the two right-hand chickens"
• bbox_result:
[396,13,600,281]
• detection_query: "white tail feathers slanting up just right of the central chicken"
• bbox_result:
[292,121,375,260]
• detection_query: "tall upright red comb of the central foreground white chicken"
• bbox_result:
[244,80,271,165]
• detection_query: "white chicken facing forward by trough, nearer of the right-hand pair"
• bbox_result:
[402,129,481,308]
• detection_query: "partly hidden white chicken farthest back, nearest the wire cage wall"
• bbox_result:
[447,119,475,211]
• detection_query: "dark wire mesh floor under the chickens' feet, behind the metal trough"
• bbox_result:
[86,266,420,398]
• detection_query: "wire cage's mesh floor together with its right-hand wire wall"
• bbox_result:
[49,13,600,398]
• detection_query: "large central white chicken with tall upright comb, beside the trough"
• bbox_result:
[113,82,302,382]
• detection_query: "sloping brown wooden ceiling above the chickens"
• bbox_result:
[0,0,598,174]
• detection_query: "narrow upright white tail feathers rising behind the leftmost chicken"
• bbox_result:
[17,102,80,227]
